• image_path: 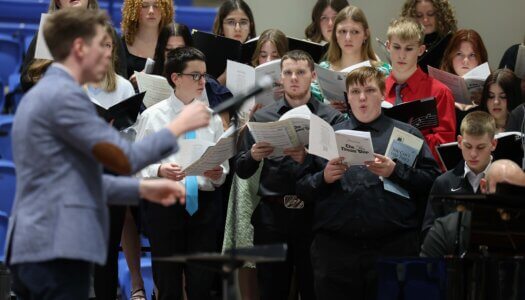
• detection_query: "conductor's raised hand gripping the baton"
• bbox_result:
[168,101,211,136]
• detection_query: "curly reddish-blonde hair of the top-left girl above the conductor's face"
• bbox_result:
[120,0,173,45]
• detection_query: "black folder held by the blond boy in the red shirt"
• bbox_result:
[383,97,439,130]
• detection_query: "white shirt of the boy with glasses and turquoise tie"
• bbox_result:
[136,93,229,191]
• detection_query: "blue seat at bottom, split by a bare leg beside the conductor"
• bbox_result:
[118,256,153,300]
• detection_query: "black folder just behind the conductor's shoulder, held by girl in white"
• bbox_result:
[93,92,146,131]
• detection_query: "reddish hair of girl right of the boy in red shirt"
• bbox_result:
[441,29,488,74]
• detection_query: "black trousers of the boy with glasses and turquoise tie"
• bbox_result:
[146,191,221,300]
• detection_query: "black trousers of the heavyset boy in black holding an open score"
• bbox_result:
[311,231,419,300]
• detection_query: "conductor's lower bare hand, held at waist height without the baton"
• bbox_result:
[139,178,186,206]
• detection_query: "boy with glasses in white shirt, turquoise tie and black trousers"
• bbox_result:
[133,47,229,299]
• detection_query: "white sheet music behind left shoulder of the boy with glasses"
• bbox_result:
[135,71,173,107]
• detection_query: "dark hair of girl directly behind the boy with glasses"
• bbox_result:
[151,23,193,75]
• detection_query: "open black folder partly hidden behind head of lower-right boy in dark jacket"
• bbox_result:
[436,131,523,170]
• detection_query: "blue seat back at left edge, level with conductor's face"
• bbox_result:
[0,34,22,89]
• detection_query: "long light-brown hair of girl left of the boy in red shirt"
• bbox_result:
[326,5,377,64]
